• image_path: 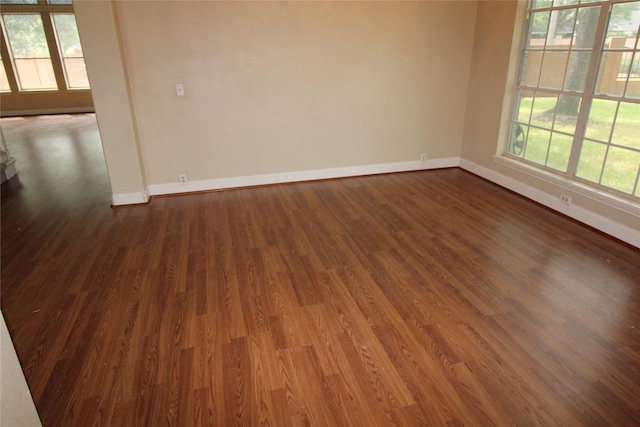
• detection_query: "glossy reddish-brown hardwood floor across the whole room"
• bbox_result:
[1,115,640,426]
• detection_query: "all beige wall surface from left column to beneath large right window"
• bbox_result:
[76,0,638,230]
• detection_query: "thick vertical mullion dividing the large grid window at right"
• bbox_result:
[567,3,611,176]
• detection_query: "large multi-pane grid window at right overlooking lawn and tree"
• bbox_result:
[507,0,640,199]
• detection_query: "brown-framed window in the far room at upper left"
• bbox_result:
[0,0,89,92]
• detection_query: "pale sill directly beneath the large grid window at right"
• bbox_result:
[493,155,640,217]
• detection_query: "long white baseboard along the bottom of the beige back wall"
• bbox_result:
[149,157,459,196]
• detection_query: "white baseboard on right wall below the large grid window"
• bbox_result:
[460,159,640,248]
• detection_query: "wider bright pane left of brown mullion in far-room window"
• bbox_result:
[2,13,57,90]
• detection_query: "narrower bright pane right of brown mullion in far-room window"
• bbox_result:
[53,13,89,89]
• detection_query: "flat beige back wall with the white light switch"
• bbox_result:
[117,1,476,185]
